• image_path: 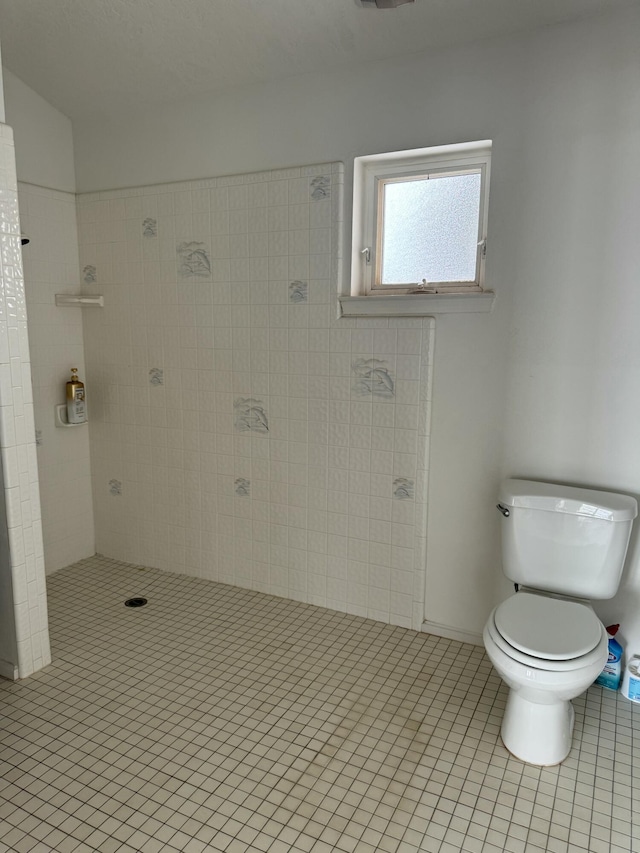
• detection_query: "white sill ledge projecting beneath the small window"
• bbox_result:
[339,290,496,317]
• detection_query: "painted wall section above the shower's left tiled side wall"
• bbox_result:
[3,68,76,192]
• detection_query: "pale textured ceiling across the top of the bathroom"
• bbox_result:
[0,0,638,119]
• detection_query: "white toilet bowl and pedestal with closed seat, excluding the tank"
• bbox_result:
[483,591,608,766]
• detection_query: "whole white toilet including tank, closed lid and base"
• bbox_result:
[483,479,638,766]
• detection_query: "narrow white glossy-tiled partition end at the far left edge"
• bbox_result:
[0,125,51,678]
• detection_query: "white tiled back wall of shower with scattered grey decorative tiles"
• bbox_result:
[78,163,432,628]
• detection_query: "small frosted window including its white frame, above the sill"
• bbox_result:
[351,141,491,296]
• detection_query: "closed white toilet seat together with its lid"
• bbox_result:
[487,592,604,672]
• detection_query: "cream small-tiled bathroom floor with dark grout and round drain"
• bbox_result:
[0,558,640,853]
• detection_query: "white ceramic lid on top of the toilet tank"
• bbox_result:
[498,480,638,521]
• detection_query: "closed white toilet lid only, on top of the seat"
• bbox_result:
[494,592,602,660]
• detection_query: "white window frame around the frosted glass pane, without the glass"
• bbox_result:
[351,140,491,297]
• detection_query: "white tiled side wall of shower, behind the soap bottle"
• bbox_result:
[18,183,95,572]
